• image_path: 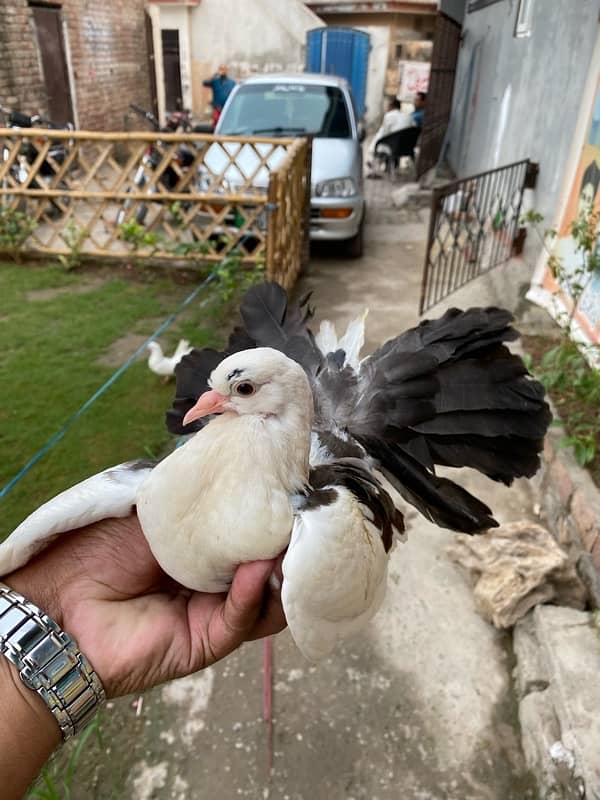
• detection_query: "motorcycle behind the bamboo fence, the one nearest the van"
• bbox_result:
[116,103,203,225]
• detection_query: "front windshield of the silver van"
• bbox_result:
[218,83,352,139]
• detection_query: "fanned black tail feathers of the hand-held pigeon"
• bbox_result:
[162,283,551,533]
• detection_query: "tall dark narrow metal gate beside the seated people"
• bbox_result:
[417,12,461,177]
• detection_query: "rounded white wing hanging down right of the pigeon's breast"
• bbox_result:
[281,488,388,661]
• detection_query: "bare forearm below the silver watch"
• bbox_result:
[0,655,61,800]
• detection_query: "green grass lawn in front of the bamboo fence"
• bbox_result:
[0,263,227,539]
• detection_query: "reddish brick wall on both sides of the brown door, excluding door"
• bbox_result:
[0,0,151,130]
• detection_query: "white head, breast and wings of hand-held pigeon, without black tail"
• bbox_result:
[0,348,394,660]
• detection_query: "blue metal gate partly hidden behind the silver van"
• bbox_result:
[306,27,371,117]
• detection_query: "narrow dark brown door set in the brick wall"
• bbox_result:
[31,5,73,125]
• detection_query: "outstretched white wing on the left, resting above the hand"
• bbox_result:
[0,462,152,575]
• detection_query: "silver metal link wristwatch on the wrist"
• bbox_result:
[0,583,106,739]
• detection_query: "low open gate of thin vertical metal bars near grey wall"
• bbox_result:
[419,159,538,314]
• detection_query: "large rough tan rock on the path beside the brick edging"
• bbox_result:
[447,520,586,628]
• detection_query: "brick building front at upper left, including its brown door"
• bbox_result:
[0,0,152,130]
